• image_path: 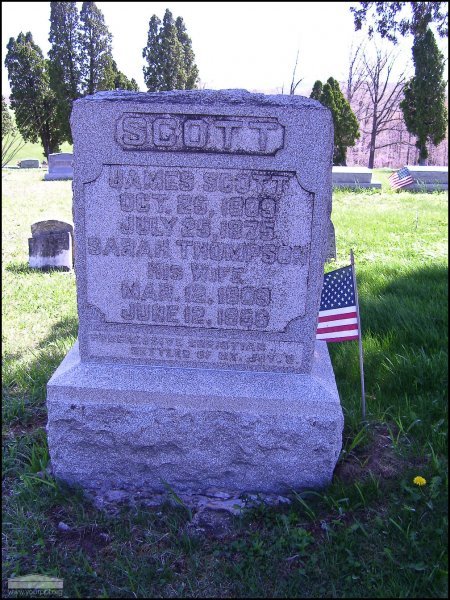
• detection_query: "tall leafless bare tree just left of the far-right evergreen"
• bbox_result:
[361,48,407,169]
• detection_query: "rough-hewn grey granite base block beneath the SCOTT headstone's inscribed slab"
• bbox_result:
[47,342,343,499]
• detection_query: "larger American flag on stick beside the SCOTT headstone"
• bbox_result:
[316,265,359,342]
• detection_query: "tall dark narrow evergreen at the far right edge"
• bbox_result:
[400,29,447,165]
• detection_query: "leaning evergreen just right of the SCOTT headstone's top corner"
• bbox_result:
[310,77,360,166]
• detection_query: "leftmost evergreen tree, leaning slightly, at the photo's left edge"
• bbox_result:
[5,32,63,157]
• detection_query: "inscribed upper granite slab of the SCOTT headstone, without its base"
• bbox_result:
[71,90,333,373]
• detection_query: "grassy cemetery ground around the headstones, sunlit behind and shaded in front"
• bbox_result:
[2,170,448,598]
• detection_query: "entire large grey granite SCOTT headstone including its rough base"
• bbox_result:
[47,90,343,497]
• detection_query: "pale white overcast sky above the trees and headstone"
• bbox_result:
[2,2,448,96]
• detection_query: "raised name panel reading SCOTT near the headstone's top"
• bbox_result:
[116,113,284,156]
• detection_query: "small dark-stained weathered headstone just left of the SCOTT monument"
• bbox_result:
[28,219,73,271]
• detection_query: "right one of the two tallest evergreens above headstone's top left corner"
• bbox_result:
[80,2,113,95]
